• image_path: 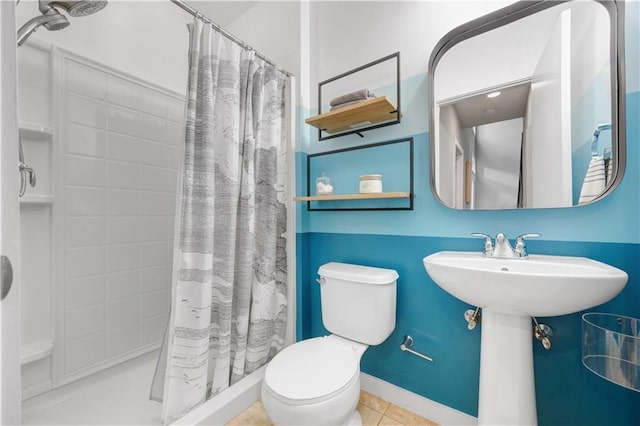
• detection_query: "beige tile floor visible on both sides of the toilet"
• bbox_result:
[227,391,437,426]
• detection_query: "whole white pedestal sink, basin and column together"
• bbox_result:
[423,251,628,425]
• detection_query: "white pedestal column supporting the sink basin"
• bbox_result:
[478,308,537,425]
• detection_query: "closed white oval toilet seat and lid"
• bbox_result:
[264,337,360,405]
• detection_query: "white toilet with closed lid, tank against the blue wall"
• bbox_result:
[262,262,398,425]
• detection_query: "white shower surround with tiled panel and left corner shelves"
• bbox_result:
[18,35,184,426]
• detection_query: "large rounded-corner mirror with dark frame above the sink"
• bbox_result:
[429,0,626,210]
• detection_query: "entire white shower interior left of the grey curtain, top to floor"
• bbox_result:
[5,0,293,424]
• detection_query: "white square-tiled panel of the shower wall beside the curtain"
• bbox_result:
[56,53,184,381]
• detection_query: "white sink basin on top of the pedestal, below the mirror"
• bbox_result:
[423,251,627,316]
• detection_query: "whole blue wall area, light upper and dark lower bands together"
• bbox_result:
[296,2,640,425]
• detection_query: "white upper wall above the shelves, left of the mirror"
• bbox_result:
[310,1,513,107]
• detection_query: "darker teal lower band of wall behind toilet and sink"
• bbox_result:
[298,233,640,425]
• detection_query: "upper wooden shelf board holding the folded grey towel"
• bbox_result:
[305,96,398,134]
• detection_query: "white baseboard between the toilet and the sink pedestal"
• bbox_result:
[360,373,478,425]
